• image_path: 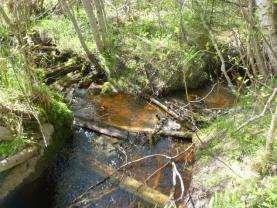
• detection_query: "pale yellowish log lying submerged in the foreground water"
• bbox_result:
[91,161,169,207]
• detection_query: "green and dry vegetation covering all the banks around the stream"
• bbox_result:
[0,0,277,207]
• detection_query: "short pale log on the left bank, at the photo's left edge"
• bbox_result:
[0,147,38,173]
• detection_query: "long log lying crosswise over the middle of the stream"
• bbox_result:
[74,117,192,139]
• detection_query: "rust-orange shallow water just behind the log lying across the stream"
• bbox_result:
[87,93,163,131]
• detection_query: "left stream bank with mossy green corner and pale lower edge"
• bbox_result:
[0,97,73,204]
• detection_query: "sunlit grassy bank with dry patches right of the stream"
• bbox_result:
[194,85,277,208]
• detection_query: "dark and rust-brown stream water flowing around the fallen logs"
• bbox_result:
[0,84,234,208]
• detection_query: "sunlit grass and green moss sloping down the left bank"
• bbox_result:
[0,15,72,157]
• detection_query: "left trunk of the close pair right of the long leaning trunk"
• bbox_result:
[82,0,104,52]
